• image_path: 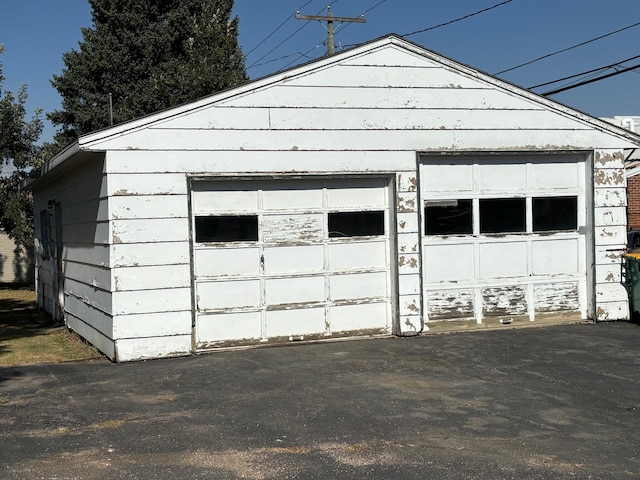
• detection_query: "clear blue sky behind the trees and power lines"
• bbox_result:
[0,0,640,140]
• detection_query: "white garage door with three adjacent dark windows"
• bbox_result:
[420,155,587,323]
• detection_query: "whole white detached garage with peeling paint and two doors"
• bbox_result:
[27,35,640,361]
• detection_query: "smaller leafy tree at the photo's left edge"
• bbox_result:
[0,45,43,249]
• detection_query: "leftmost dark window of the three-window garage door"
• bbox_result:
[424,200,473,235]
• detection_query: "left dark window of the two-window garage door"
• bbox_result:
[196,215,258,243]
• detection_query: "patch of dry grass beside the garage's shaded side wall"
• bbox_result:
[0,287,101,367]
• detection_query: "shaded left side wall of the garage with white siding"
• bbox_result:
[34,156,113,350]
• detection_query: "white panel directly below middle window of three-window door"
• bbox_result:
[478,241,527,280]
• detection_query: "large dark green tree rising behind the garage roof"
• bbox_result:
[47,0,247,146]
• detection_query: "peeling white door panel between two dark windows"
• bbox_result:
[260,214,324,243]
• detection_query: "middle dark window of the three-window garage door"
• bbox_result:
[480,198,527,233]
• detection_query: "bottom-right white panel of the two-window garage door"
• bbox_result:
[329,302,390,333]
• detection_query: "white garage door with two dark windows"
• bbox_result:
[192,178,391,349]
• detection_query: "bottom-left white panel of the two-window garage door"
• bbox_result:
[196,312,262,343]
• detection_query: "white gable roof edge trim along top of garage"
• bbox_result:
[26,34,640,186]
